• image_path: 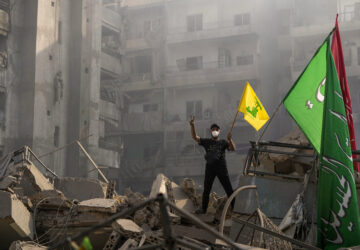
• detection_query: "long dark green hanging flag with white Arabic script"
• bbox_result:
[317,37,360,249]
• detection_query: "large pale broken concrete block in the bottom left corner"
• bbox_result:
[0,191,34,248]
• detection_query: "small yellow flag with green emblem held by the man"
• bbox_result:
[238,82,269,130]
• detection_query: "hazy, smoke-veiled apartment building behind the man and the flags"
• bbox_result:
[119,0,360,193]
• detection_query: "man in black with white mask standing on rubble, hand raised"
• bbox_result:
[190,116,235,214]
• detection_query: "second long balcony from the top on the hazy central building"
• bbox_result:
[166,59,259,87]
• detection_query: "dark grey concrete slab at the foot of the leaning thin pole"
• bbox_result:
[54,177,107,201]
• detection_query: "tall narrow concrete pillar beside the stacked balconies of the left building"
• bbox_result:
[79,0,102,177]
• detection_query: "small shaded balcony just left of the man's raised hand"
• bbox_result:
[122,111,163,133]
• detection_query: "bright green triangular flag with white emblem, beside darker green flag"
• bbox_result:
[283,42,327,153]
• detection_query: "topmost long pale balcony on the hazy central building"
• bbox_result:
[167,21,257,44]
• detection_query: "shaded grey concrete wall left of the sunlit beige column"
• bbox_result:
[4,0,37,153]
